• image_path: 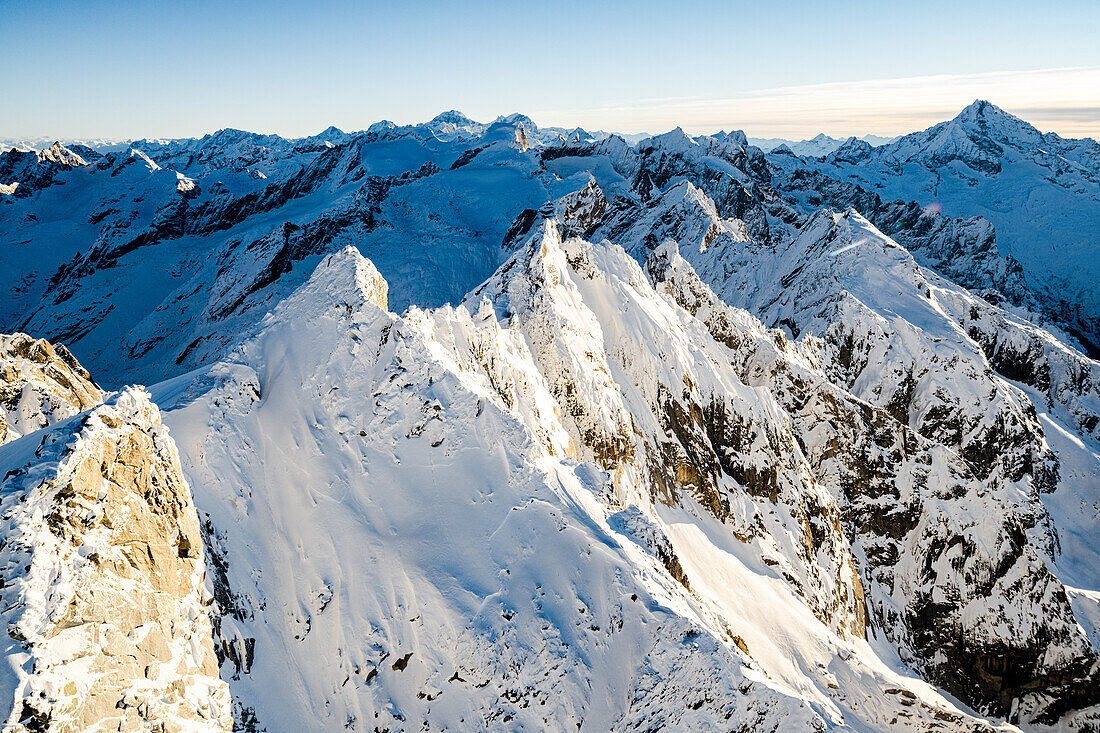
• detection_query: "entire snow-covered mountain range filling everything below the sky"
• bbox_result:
[0,102,1100,733]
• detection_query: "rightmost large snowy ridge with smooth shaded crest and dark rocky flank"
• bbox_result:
[629,195,1097,722]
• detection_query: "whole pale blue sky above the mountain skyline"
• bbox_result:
[0,0,1100,140]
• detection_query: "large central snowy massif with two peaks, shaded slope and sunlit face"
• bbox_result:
[161,238,1012,730]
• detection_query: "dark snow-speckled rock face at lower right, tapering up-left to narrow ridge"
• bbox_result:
[648,241,1100,723]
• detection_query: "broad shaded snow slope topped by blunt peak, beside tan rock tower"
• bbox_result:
[165,241,844,730]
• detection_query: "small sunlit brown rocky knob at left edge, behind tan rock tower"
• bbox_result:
[0,333,103,444]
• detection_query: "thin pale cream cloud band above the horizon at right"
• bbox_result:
[536,67,1100,139]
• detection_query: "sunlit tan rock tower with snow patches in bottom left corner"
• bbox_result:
[0,389,232,733]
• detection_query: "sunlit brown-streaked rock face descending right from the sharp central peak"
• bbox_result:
[469,222,866,637]
